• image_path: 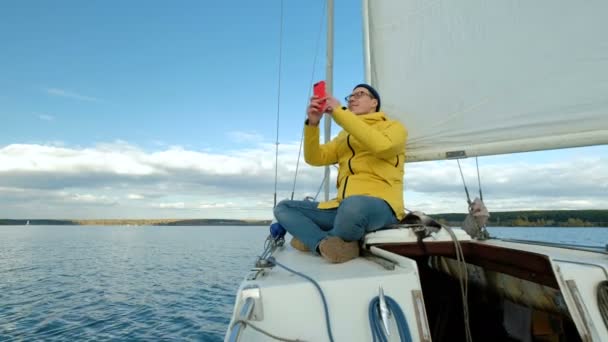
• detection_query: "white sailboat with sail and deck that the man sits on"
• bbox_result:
[225,0,608,342]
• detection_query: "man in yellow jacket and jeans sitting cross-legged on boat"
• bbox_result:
[274,84,407,263]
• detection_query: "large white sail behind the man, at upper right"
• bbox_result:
[364,0,608,161]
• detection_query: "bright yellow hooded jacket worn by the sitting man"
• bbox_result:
[304,107,407,220]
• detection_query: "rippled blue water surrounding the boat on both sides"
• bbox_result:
[0,226,608,341]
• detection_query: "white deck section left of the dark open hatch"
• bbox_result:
[226,246,428,342]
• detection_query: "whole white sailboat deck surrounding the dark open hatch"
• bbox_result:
[226,228,608,341]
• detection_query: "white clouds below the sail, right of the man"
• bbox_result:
[405,156,608,213]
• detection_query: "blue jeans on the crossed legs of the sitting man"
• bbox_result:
[274,196,398,252]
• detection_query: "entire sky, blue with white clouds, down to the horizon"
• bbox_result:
[0,0,608,218]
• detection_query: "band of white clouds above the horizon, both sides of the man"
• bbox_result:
[0,141,608,219]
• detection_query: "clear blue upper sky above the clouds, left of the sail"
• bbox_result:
[0,1,362,149]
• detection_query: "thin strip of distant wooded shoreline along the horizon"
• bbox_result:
[0,210,608,227]
